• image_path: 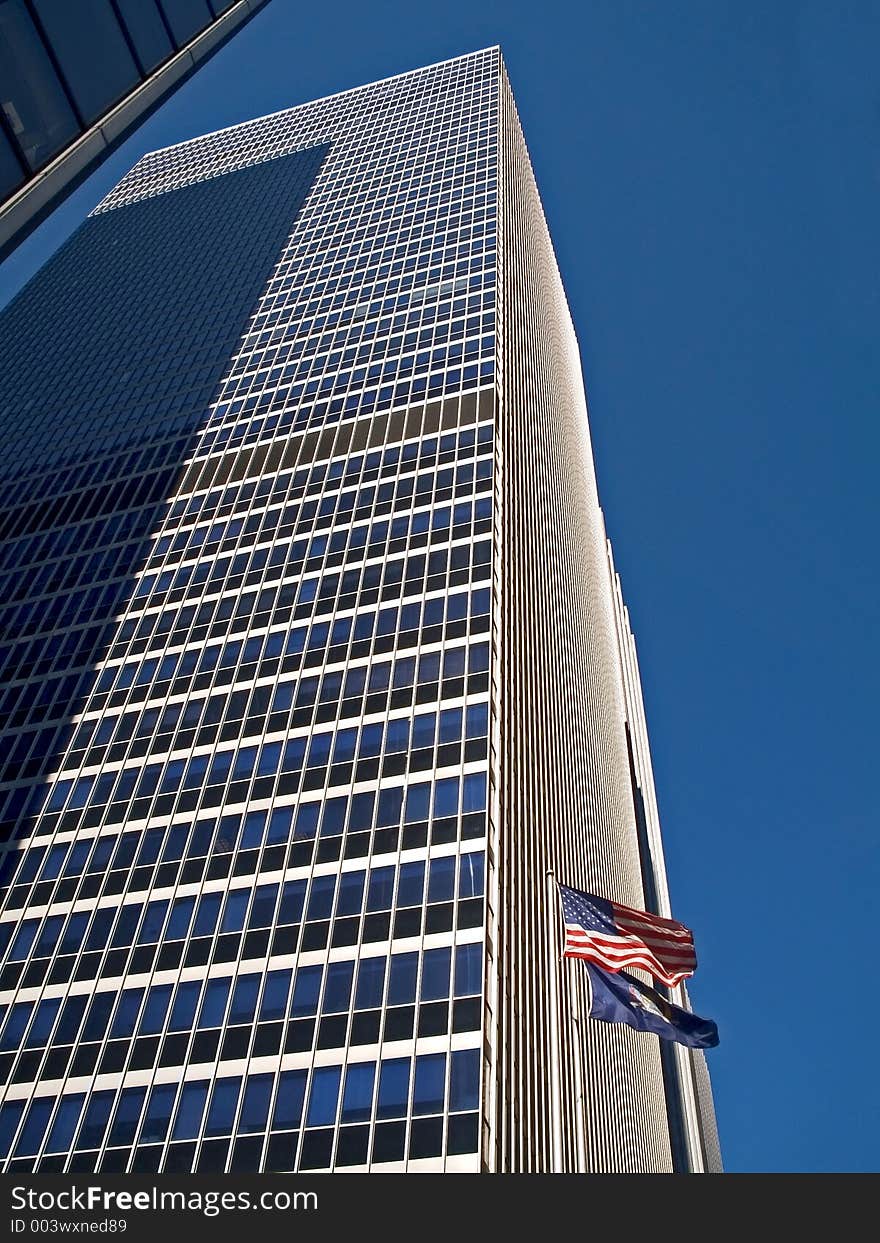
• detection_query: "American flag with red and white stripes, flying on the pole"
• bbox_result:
[559,885,696,988]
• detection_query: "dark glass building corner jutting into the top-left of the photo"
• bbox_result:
[0,0,267,259]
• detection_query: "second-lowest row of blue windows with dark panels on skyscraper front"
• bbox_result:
[0,942,482,1083]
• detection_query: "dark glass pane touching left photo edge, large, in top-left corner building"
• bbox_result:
[0,0,80,169]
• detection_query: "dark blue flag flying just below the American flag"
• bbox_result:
[585,962,718,1049]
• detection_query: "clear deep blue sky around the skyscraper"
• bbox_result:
[0,0,880,1171]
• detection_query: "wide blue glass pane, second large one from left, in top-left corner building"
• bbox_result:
[34,0,140,124]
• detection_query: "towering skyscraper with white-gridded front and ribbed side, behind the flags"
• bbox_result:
[0,48,717,1171]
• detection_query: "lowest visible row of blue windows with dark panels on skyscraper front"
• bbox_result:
[0,1049,480,1172]
